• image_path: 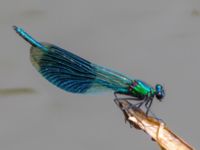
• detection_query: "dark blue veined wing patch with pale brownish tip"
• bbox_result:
[31,43,96,93]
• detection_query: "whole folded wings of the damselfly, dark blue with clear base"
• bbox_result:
[31,43,132,93]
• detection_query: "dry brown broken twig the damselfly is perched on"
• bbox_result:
[117,101,193,150]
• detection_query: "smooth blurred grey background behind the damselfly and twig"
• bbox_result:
[0,0,200,150]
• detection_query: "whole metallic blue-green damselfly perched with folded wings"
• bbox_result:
[14,26,165,114]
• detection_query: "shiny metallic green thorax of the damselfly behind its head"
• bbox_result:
[129,80,156,97]
